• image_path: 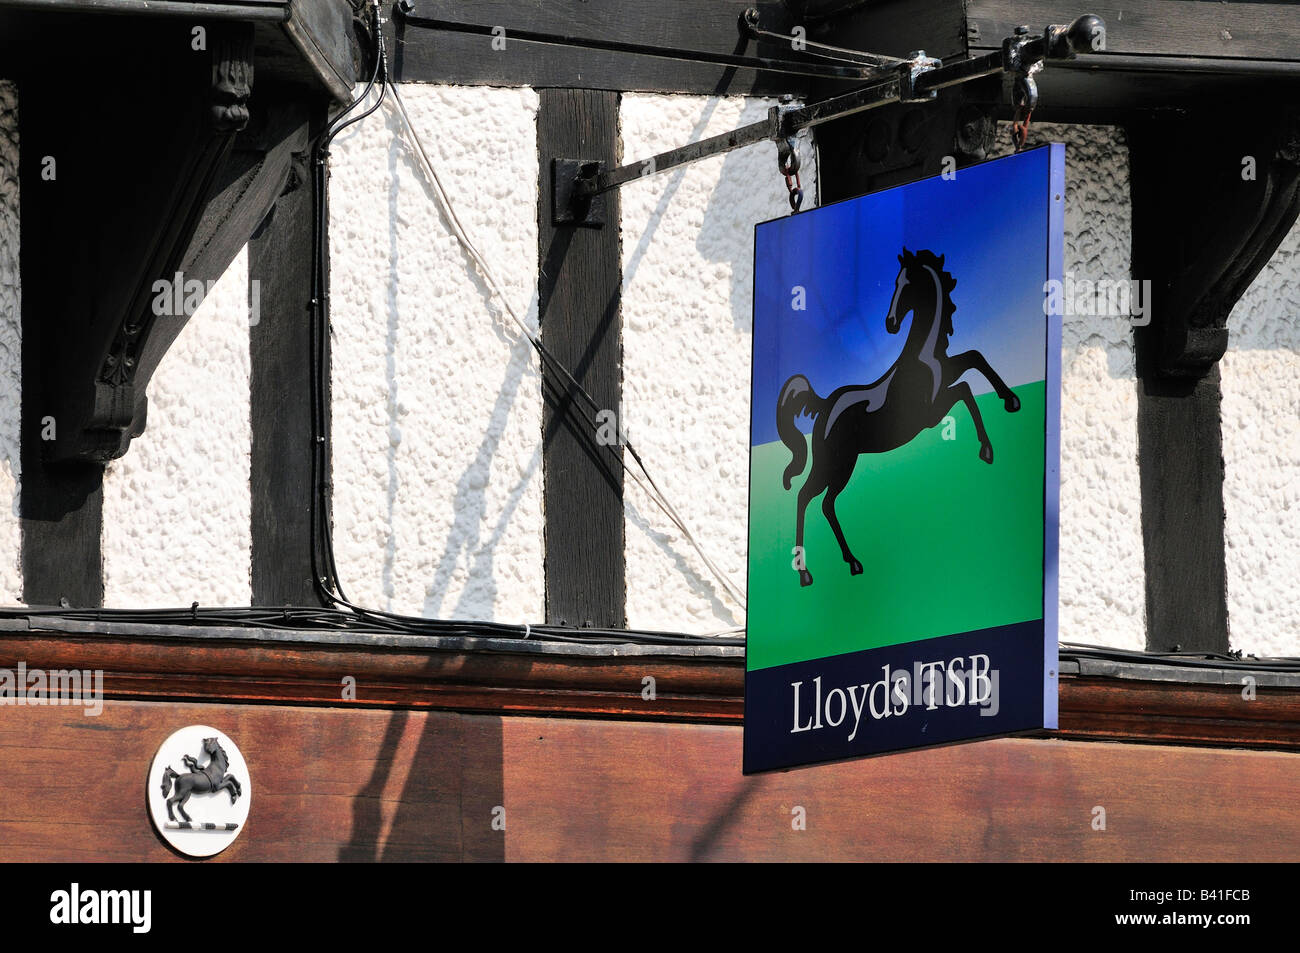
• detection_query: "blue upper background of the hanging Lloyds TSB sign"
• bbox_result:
[751,147,1052,446]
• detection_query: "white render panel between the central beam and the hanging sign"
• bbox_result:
[621,94,816,632]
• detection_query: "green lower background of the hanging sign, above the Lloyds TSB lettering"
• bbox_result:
[746,381,1045,671]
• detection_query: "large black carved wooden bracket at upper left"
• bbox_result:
[23,22,314,463]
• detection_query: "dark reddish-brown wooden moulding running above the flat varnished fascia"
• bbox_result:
[0,629,1300,751]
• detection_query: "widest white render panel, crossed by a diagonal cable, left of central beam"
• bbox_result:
[329,85,545,623]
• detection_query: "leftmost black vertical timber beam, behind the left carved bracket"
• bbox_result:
[18,75,104,607]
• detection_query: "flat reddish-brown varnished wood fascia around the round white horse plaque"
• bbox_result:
[0,702,1300,862]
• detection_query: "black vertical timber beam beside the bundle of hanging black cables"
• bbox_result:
[248,109,329,606]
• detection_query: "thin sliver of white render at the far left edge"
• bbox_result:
[0,82,22,603]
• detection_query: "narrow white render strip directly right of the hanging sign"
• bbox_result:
[997,124,1147,650]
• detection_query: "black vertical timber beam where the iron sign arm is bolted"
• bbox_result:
[537,90,627,627]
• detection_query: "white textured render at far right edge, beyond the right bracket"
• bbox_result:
[1221,219,1300,655]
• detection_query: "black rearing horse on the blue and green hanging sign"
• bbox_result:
[776,248,1021,585]
